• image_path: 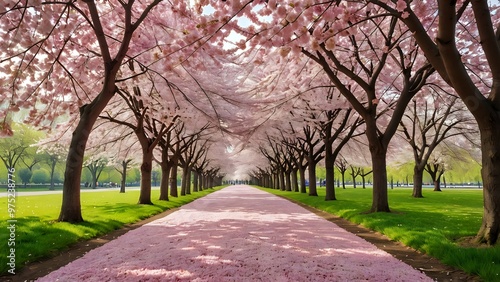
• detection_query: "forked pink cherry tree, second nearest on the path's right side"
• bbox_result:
[205,1,433,211]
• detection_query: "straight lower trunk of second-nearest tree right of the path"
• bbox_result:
[370,148,390,212]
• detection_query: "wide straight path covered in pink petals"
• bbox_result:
[38,186,432,282]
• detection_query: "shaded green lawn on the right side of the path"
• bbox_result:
[263,188,500,281]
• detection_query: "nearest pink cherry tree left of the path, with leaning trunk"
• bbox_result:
[0,0,248,222]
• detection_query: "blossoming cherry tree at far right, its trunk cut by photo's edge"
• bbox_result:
[362,0,500,245]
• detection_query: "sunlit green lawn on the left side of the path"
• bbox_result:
[0,187,220,275]
